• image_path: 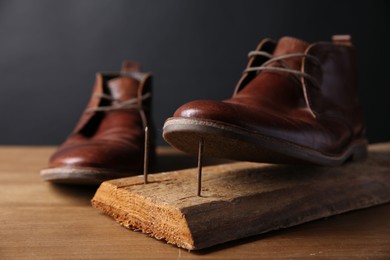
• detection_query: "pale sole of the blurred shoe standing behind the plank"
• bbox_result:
[40,167,140,185]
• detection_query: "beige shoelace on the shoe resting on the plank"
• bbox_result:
[244,51,321,117]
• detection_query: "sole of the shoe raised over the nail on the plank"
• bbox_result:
[163,118,367,166]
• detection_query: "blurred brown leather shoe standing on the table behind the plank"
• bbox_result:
[41,62,154,184]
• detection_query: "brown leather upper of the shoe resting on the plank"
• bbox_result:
[174,37,364,154]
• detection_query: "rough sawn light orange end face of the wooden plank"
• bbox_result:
[92,181,193,248]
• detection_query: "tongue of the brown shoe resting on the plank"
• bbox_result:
[273,37,309,70]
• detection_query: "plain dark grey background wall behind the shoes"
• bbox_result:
[0,0,390,145]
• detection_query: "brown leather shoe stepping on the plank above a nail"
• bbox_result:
[163,36,367,165]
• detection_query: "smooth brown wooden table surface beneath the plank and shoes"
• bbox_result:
[0,146,390,259]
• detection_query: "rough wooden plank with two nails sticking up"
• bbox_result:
[92,143,390,250]
